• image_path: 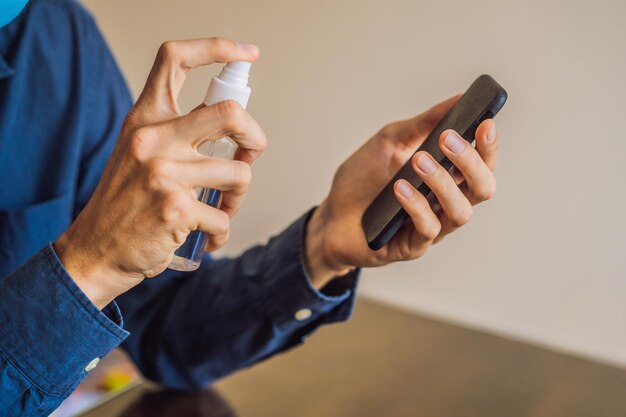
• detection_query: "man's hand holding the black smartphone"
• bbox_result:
[305,96,498,288]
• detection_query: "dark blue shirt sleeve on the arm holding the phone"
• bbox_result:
[118,212,359,388]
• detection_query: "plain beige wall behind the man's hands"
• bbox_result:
[85,0,626,365]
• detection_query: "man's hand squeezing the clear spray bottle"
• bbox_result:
[55,38,266,308]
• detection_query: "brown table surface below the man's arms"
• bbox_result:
[78,299,626,417]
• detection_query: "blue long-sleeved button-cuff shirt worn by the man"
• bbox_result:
[0,0,358,416]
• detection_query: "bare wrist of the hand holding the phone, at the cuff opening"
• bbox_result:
[304,203,354,290]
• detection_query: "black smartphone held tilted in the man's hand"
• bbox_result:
[361,74,507,250]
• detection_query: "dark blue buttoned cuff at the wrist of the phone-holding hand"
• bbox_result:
[263,208,360,330]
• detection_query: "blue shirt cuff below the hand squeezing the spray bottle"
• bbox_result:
[0,244,129,396]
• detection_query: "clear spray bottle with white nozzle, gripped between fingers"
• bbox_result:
[169,61,252,271]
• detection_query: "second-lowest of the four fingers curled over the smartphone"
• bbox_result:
[411,152,473,228]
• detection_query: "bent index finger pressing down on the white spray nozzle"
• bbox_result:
[137,38,259,117]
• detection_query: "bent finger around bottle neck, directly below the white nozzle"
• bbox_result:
[160,100,267,163]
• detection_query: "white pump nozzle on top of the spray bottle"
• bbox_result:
[204,61,252,108]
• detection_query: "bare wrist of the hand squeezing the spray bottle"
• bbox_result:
[53,231,125,310]
